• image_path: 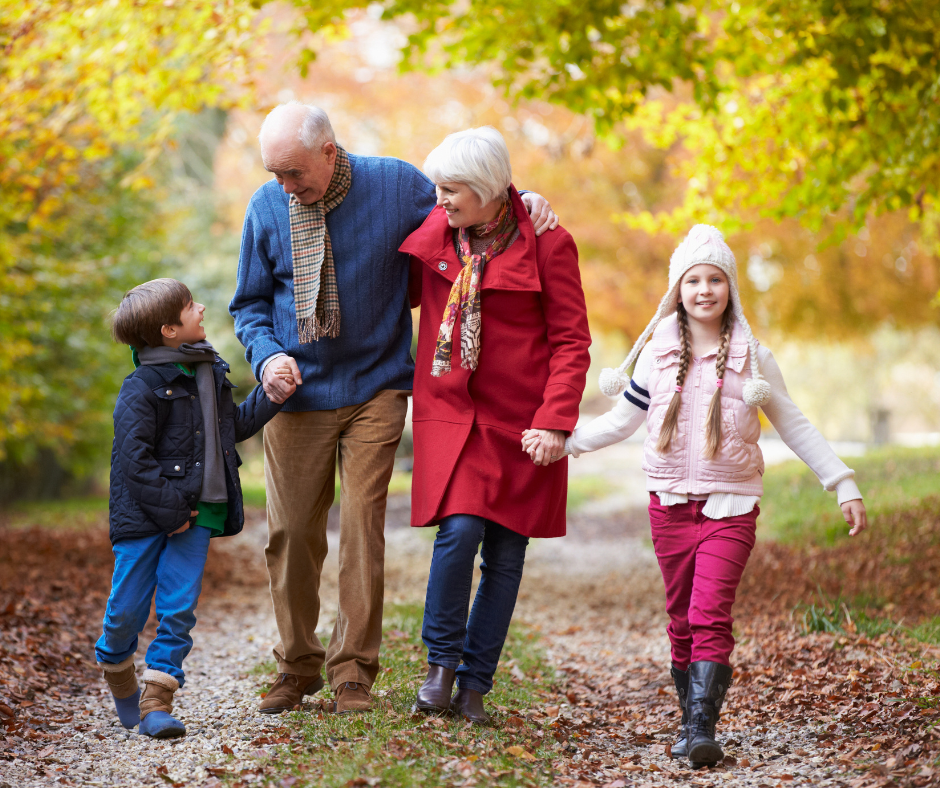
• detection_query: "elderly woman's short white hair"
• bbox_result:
[424,126,512,205]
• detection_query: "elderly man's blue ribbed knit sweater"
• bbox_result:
[229,154,435,411]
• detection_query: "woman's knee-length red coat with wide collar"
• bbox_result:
[401,189,591,537]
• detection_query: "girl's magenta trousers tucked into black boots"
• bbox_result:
[649,493,760,670]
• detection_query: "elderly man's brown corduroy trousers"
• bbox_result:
[264,390,411,689]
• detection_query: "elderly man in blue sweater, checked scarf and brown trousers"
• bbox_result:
[229,102,557,714]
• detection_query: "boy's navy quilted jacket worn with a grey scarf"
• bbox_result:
[109,357,281,544]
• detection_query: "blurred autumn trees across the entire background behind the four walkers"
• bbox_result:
[0,0,940,498]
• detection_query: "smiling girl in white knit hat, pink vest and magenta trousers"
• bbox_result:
[524,224,867,766]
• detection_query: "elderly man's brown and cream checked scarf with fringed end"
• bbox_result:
[289,146,352,345]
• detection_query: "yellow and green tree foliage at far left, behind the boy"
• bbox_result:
[0,0,254,497]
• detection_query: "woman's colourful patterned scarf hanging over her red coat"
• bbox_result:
[431,195,518,378]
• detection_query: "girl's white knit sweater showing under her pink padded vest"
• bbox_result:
[565,345,862,519]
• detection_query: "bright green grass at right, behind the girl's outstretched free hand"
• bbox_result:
[760,446,940,545]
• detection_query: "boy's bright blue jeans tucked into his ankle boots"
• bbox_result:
[95,525,211,686]
